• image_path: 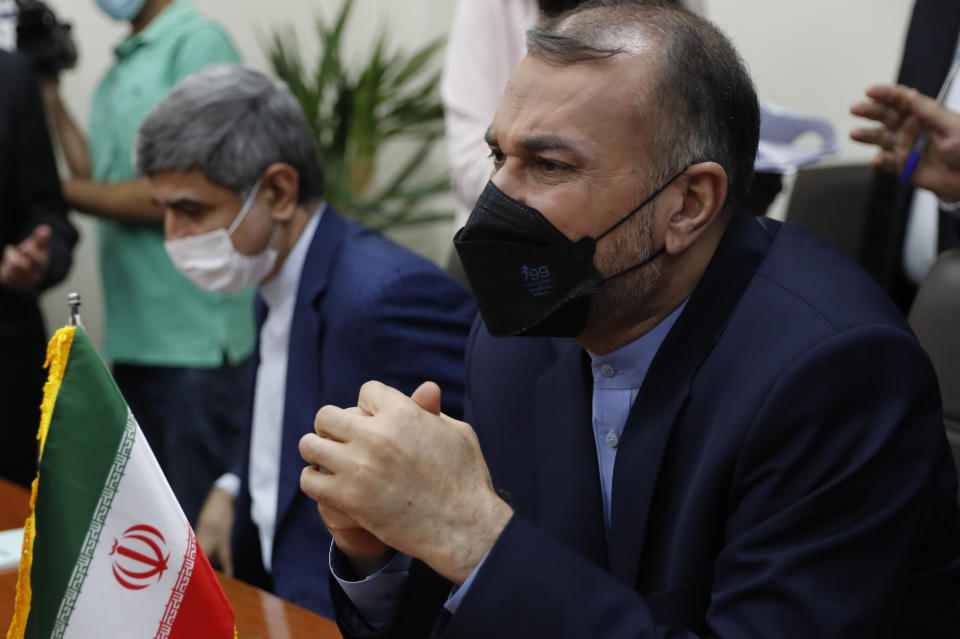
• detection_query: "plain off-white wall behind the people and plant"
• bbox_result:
[28,0,912,344]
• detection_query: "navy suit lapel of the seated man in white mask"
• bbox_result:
[274,205,350,536]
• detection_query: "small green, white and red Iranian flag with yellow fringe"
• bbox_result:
[7,327,235,639]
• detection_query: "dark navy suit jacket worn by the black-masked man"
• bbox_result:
[335,217,960,639]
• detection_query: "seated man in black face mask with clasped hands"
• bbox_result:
[300,0,960,639]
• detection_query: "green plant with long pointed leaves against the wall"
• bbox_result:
[268,0,453,230]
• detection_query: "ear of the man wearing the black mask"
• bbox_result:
[664,162,727,255]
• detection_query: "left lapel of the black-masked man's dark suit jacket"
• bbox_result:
[536,340,607,567]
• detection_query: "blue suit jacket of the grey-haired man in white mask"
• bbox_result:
[232,206,476,616]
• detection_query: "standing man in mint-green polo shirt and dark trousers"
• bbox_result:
[44,0,254,524]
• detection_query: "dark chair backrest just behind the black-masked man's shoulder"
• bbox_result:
[786,164,873,259]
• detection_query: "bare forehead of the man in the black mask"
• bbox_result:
[490,55,653,153]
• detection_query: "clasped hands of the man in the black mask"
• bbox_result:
[300,382,512,583]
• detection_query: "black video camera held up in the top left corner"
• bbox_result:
[16,0,77,77]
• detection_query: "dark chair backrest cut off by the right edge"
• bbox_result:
[909,249,960,492]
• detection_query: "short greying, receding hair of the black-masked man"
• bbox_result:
[527,0,760,212]
